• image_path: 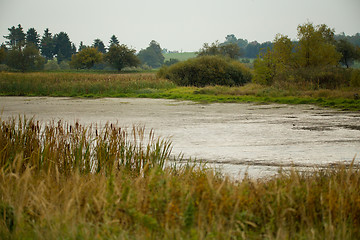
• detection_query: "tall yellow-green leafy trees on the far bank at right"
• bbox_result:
[254,23,349,88]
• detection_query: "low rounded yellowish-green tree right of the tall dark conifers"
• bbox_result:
[70,47,102,69]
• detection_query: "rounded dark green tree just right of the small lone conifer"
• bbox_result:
[105,44,140,71]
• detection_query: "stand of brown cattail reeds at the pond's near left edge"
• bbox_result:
[0,117,171,175]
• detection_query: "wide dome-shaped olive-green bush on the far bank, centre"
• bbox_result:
[158,56,252,87]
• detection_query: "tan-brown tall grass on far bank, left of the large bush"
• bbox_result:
[0,72,175,97]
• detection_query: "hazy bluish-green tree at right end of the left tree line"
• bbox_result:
[138,40,165,68]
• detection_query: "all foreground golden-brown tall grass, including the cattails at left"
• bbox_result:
[0,116,360,239]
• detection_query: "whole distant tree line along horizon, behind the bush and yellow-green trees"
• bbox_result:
[0,23,360,71]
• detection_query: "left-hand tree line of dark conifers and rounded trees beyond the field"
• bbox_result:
[0,24,164,71]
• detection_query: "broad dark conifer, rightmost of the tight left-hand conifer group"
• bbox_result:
[54,32,72,63]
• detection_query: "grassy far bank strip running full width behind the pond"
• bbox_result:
[0,72,360,111]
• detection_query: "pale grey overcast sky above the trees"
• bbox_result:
[0,0,360,51]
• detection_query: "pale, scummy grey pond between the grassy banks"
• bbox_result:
[0,97,360,178]
